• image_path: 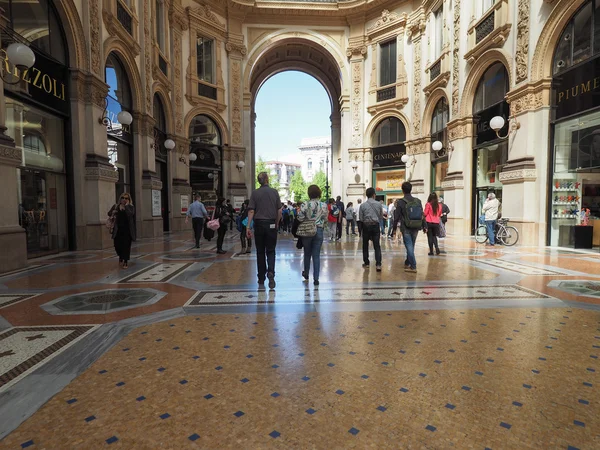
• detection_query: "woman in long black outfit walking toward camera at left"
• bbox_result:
[108,192,136,269]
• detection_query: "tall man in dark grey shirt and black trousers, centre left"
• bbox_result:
[247,172,283,289]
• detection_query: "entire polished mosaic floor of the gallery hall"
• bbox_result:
[0,233,600,450]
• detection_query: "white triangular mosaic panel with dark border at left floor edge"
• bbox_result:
[0,325,96,392]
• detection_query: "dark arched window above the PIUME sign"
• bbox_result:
[552,0,600,74]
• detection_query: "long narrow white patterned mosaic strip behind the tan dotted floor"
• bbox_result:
[187,285,548,306]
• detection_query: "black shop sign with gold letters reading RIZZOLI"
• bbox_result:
[0,47,69,114]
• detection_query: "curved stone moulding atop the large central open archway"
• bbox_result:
[243,30,349,98]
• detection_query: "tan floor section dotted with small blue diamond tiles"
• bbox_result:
[2,308,600,449]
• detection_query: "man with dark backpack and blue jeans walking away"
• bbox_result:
[394,181,425,273]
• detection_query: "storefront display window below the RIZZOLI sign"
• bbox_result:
[6,97,68,257]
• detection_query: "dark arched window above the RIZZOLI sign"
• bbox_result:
[6,0,67,65]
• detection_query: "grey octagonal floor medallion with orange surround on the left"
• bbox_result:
[42,289,166,315]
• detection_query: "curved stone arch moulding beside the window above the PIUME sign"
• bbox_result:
[531,0,587,82]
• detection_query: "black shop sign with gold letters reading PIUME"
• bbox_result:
[552,58,600,119]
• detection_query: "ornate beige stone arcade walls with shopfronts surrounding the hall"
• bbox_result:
[0,0,600,271]
